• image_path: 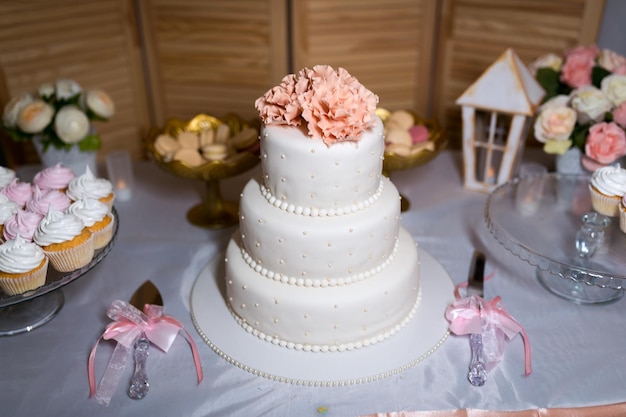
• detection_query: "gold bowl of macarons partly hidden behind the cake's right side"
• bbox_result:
[376,107,448,211]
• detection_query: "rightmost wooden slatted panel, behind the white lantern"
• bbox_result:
[433,0,604,148]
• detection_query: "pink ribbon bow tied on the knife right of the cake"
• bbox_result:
[446,273,532,375]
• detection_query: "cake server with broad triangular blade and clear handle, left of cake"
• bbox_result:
[128,280,163,400]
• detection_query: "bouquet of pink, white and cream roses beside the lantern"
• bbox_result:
[530,45,626,171]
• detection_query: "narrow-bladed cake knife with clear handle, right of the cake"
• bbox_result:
[467,250,487,387]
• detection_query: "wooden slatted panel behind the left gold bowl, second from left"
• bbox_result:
[139,0,287,126]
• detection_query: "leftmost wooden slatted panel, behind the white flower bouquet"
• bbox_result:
[0,0,147,166]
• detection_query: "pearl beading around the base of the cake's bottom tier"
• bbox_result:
[228,287,422,353]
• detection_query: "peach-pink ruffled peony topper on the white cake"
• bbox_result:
[254,65,378,146]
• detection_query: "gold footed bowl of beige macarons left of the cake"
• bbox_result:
[146,114,259,229]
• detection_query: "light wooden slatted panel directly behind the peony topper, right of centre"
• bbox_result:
[291,0,438,114]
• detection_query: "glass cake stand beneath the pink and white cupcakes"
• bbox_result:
[0,208,119,336]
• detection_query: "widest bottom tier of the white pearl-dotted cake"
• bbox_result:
[225,228,420,352]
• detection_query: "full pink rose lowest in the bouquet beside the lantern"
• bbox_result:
[585,122,626,164]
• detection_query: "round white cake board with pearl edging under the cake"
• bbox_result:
[191,248,454,386]
